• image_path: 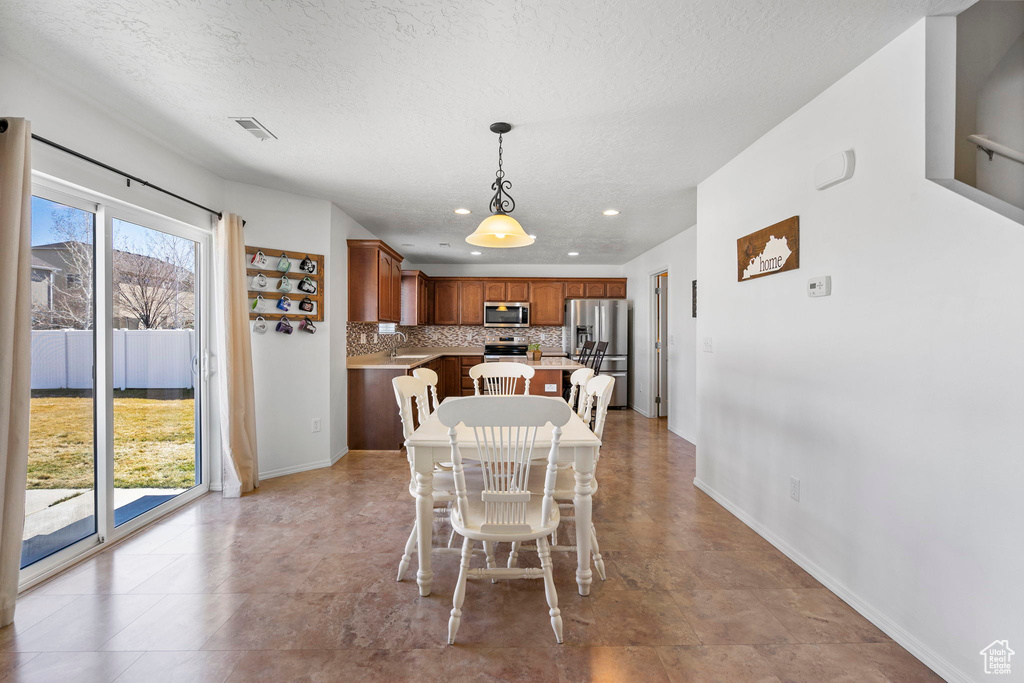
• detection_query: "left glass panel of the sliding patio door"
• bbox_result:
[22,196,97,567]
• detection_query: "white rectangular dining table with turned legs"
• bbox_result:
[406,396,601,596]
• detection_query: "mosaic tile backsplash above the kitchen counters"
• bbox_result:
[346,323,562,355]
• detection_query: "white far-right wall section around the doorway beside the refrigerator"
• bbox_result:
[623,227,700,442]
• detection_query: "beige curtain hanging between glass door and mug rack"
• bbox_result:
[216,213,259,498]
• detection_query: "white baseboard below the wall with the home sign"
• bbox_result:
[693,477,974,683]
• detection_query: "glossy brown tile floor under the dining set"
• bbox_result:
[0,412,940,683]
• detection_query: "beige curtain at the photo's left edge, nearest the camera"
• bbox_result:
[0,119,32,627]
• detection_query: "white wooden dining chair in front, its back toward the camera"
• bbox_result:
[437,396,572,644]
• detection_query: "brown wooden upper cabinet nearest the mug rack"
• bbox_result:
[348,240,402,323]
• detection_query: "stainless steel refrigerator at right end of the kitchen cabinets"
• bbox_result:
[562,299,630,408]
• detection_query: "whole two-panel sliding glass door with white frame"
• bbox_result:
[22,185,210,581]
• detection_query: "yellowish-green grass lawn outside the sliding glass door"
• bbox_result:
[28,389,196,488]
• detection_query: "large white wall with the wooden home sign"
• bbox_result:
[697,22,1024,680]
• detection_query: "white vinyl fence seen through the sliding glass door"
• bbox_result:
[32,330,196,389]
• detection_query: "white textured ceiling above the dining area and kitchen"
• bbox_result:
[0,0,971,263]
